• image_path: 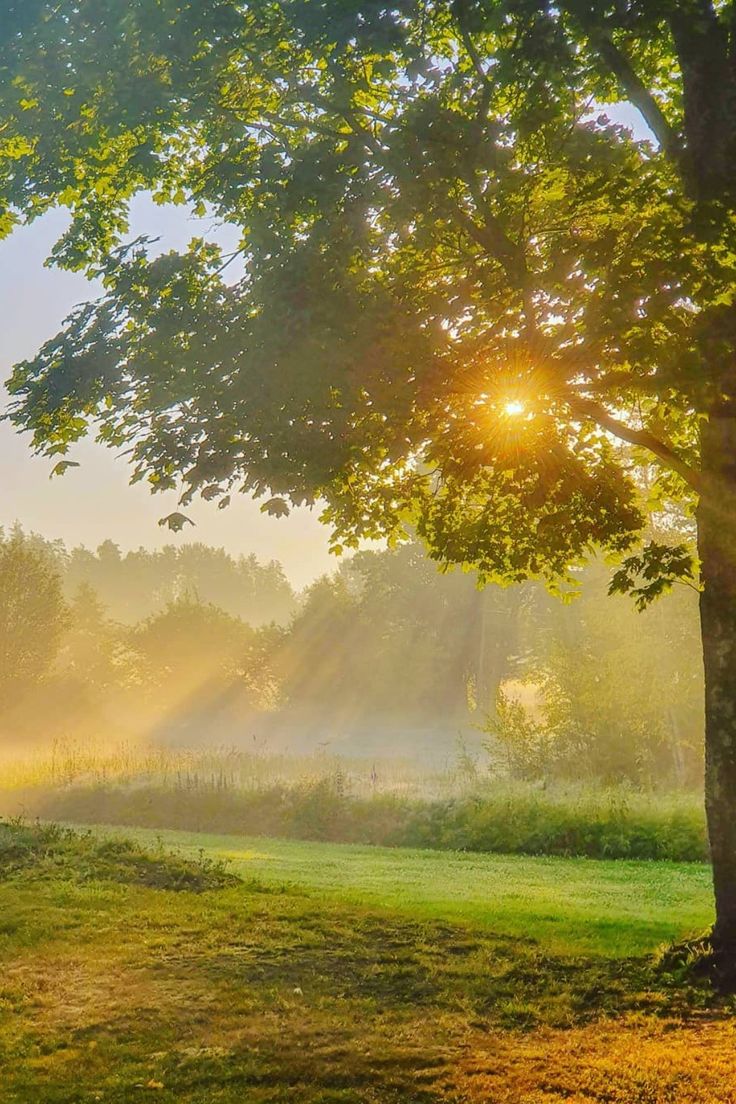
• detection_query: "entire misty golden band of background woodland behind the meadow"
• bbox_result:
[0,527,703,789]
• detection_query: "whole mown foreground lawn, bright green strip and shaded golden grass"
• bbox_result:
[0,831,736,1104]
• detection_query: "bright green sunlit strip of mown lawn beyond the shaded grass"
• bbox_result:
[68,828,713,957]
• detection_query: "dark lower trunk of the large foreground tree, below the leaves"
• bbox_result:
[697,408,736,983]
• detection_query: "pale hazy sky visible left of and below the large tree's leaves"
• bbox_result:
[0,200,337,586]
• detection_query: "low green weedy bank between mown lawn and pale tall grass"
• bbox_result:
[21,775,707,862]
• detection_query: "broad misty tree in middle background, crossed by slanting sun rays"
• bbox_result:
[272,543,519,728]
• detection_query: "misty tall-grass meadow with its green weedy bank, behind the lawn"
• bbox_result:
[0,744,708,862]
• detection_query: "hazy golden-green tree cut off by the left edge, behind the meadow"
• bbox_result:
[0,531,67,707]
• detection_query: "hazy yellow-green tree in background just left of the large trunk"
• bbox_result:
[511,561,703,787]
